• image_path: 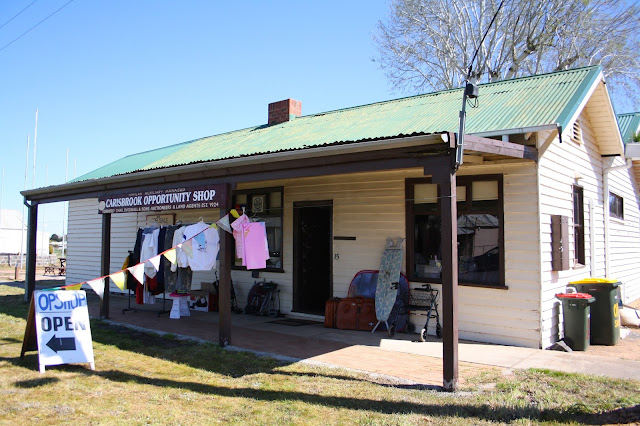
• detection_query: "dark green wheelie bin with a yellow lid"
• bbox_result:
[569,278,622,346]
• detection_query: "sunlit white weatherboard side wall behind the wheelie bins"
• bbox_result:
[539,112,640,347]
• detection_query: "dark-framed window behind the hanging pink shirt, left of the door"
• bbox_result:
[233,187,284,272]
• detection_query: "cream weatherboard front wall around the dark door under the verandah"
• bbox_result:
[233,162,540,348]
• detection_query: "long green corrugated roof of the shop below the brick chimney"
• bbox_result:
[75,66,601,181]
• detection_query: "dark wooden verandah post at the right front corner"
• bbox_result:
[433,151,458,391]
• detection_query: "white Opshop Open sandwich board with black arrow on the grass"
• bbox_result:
[20,290,95,373]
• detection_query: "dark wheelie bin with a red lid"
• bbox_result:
[556,293,596,351]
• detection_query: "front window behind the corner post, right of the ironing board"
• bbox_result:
[406,176,504,286]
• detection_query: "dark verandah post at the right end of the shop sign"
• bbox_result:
[218,184,233,346]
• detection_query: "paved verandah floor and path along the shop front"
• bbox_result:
[80,291,640,386]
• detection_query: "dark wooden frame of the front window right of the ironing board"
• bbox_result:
[405,174,508,289]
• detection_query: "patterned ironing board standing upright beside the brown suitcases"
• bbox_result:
[371,238,404,333]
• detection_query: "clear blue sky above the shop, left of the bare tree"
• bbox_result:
[0,0,392,233]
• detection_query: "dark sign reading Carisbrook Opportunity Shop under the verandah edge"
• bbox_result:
[98,185,225,213]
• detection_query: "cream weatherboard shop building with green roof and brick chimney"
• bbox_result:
[23,67,640,348]
